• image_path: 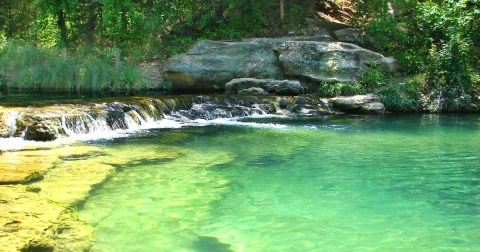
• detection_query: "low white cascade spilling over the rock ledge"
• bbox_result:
[0,96,331,141]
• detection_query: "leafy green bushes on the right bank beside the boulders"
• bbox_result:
[353,0,480,112]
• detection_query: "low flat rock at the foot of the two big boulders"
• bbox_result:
[225,78,305,95]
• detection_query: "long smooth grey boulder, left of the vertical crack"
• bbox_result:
[165,33,332,91]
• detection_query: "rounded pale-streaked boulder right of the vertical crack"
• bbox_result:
[276,41,396,82]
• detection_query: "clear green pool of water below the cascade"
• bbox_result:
[80,115,480,251]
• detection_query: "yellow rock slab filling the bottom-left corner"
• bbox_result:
[0,185,94,251]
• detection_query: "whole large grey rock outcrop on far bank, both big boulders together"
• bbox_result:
[164,28,397,95]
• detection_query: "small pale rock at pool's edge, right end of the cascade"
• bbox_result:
[330,94,385,114]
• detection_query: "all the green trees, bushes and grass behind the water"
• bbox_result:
[0,0,480,111]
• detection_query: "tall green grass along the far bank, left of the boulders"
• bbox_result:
[0,43,148,93]
